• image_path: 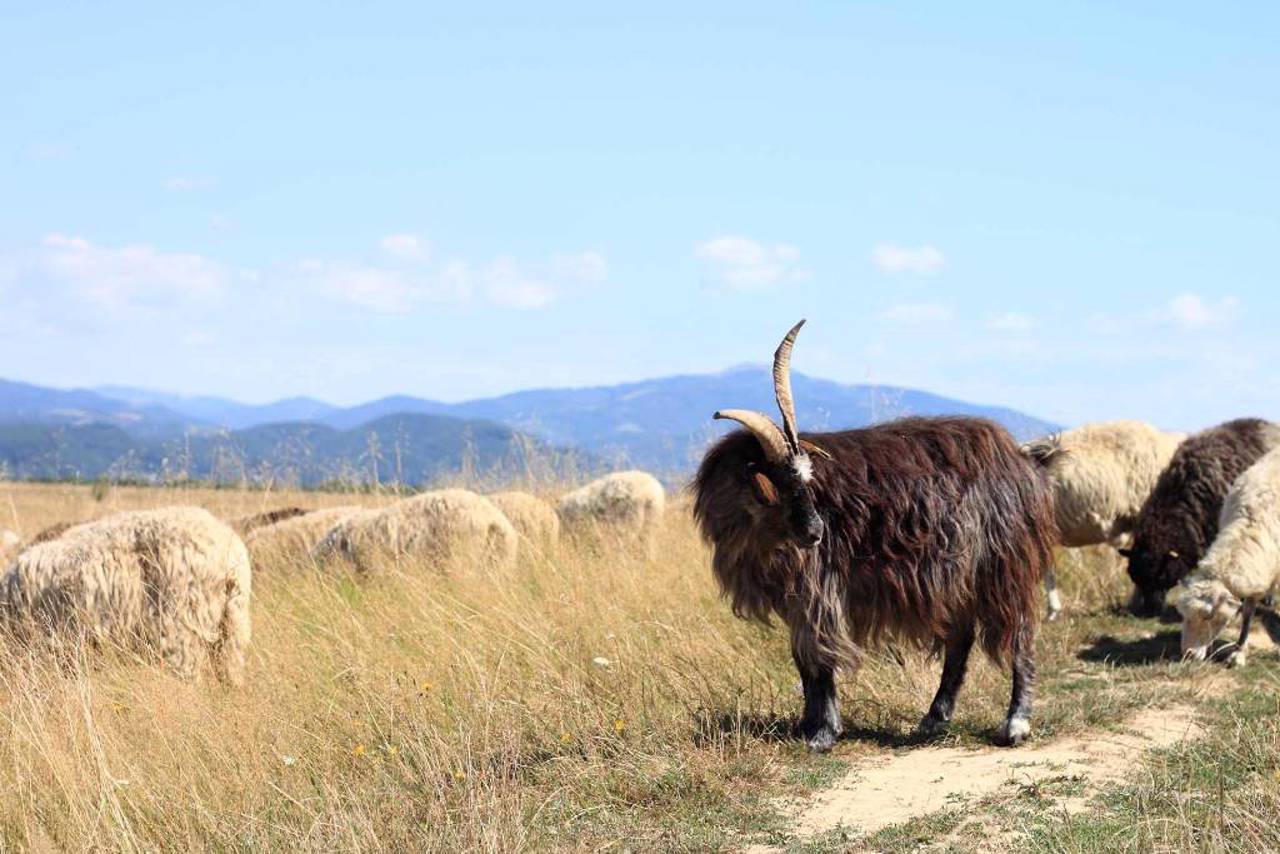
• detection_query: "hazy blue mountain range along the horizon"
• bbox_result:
[0,366,1057,484]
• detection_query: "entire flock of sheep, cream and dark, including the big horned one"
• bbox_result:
[0,321,1280,750]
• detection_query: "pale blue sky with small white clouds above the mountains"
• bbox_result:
[0,3,1280,429]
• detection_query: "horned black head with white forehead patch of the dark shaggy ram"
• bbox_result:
[714,320,828,549]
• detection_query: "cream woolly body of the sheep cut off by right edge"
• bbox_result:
[1188,448,1280,599]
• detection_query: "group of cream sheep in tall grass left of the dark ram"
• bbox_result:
[0,471,666,685]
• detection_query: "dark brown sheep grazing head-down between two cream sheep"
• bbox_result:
[1120,419,1280,616]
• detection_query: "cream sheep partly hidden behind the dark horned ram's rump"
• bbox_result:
[1023,421,1185,620]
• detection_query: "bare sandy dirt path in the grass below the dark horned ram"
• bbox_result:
[773,705,1202,837]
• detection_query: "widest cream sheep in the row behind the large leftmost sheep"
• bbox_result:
[314,489,520,572]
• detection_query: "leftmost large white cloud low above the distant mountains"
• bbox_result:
[33,234,227,307]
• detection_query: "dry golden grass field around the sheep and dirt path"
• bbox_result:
[0,484,1280,851]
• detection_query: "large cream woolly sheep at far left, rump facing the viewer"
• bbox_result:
[0,507,251,685]
